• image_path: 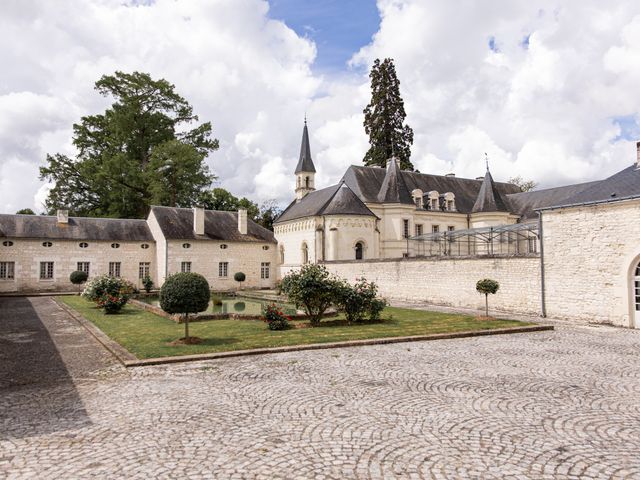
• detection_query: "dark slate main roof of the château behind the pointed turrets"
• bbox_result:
[343,165,520,213]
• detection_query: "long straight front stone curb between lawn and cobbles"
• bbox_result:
[121,325,554,367]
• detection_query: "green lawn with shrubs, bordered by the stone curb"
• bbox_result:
[59,296,531,359]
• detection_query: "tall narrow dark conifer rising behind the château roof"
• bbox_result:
[364,58,414,170]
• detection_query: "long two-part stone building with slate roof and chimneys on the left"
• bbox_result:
[0,207,278,292]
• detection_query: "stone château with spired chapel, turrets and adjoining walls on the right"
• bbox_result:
[274,125,640,328]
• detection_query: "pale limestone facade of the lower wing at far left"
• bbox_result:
[0,238,158,292]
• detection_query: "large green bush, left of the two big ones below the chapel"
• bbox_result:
[280,264,343,326]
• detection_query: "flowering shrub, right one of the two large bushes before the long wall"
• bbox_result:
[336,278,387,323]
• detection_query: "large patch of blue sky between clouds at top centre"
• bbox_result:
[269,0,380,72]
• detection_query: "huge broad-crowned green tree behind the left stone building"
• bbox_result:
[40,72,218,218]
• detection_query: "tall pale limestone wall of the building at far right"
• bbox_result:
[542,200,640,327]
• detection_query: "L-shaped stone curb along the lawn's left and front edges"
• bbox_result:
[53,299,554,367]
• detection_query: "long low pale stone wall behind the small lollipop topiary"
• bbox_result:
[302,255,541,315]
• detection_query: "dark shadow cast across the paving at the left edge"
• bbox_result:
[0,297,90,440]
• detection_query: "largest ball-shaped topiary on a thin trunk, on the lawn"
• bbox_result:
[160,273,211,343]
